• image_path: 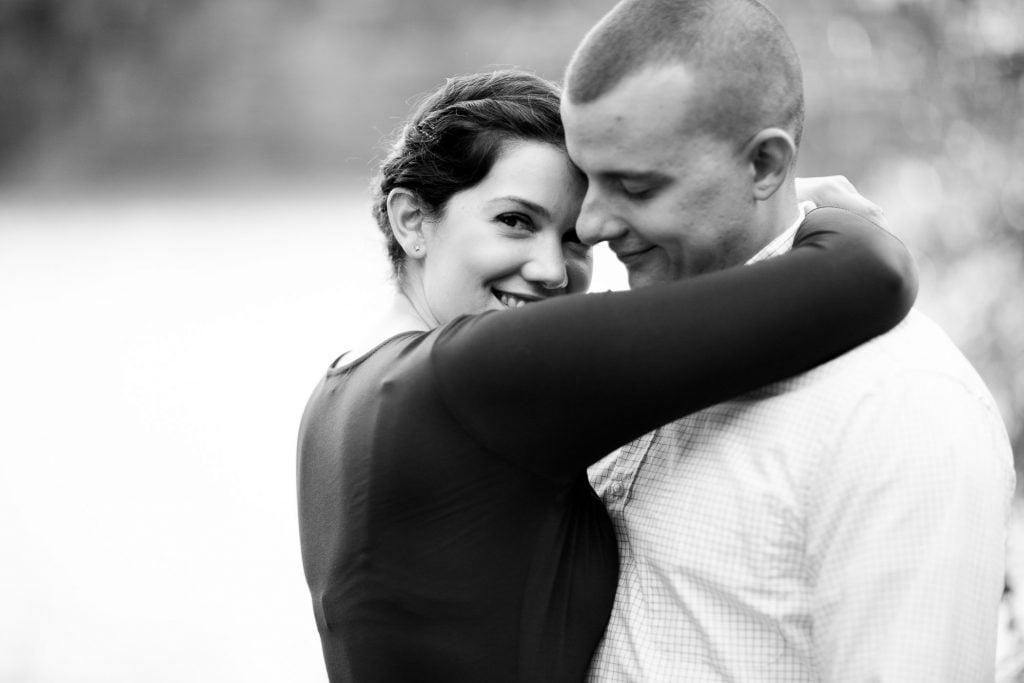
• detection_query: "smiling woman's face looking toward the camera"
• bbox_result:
[421,141,593,325]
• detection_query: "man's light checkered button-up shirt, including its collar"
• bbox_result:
[590,209,1014,683]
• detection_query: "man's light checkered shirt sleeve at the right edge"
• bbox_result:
[807,373,1014,683]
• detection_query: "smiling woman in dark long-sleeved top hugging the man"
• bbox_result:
[298,72,914,682]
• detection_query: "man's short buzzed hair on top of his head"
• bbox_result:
[563,0,804,145]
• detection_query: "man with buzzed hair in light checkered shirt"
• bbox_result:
[562,0,1014,683]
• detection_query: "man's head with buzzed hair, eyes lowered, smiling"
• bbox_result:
[562,0,804,287]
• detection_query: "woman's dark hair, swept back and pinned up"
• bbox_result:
[372,70,565,279]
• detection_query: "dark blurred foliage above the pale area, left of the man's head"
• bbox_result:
[0,0,607,179]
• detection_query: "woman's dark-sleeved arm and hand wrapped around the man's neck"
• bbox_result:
[431,209,916,478]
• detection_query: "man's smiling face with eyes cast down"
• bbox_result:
[562,66,761,288]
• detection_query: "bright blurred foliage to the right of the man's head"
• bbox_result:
[774,0,1024,478]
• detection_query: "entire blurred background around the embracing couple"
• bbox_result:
[0,0,1024,683]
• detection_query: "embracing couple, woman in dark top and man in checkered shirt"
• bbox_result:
[298,0,1014,682]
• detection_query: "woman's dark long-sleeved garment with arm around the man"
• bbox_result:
[298,209,916,683]
